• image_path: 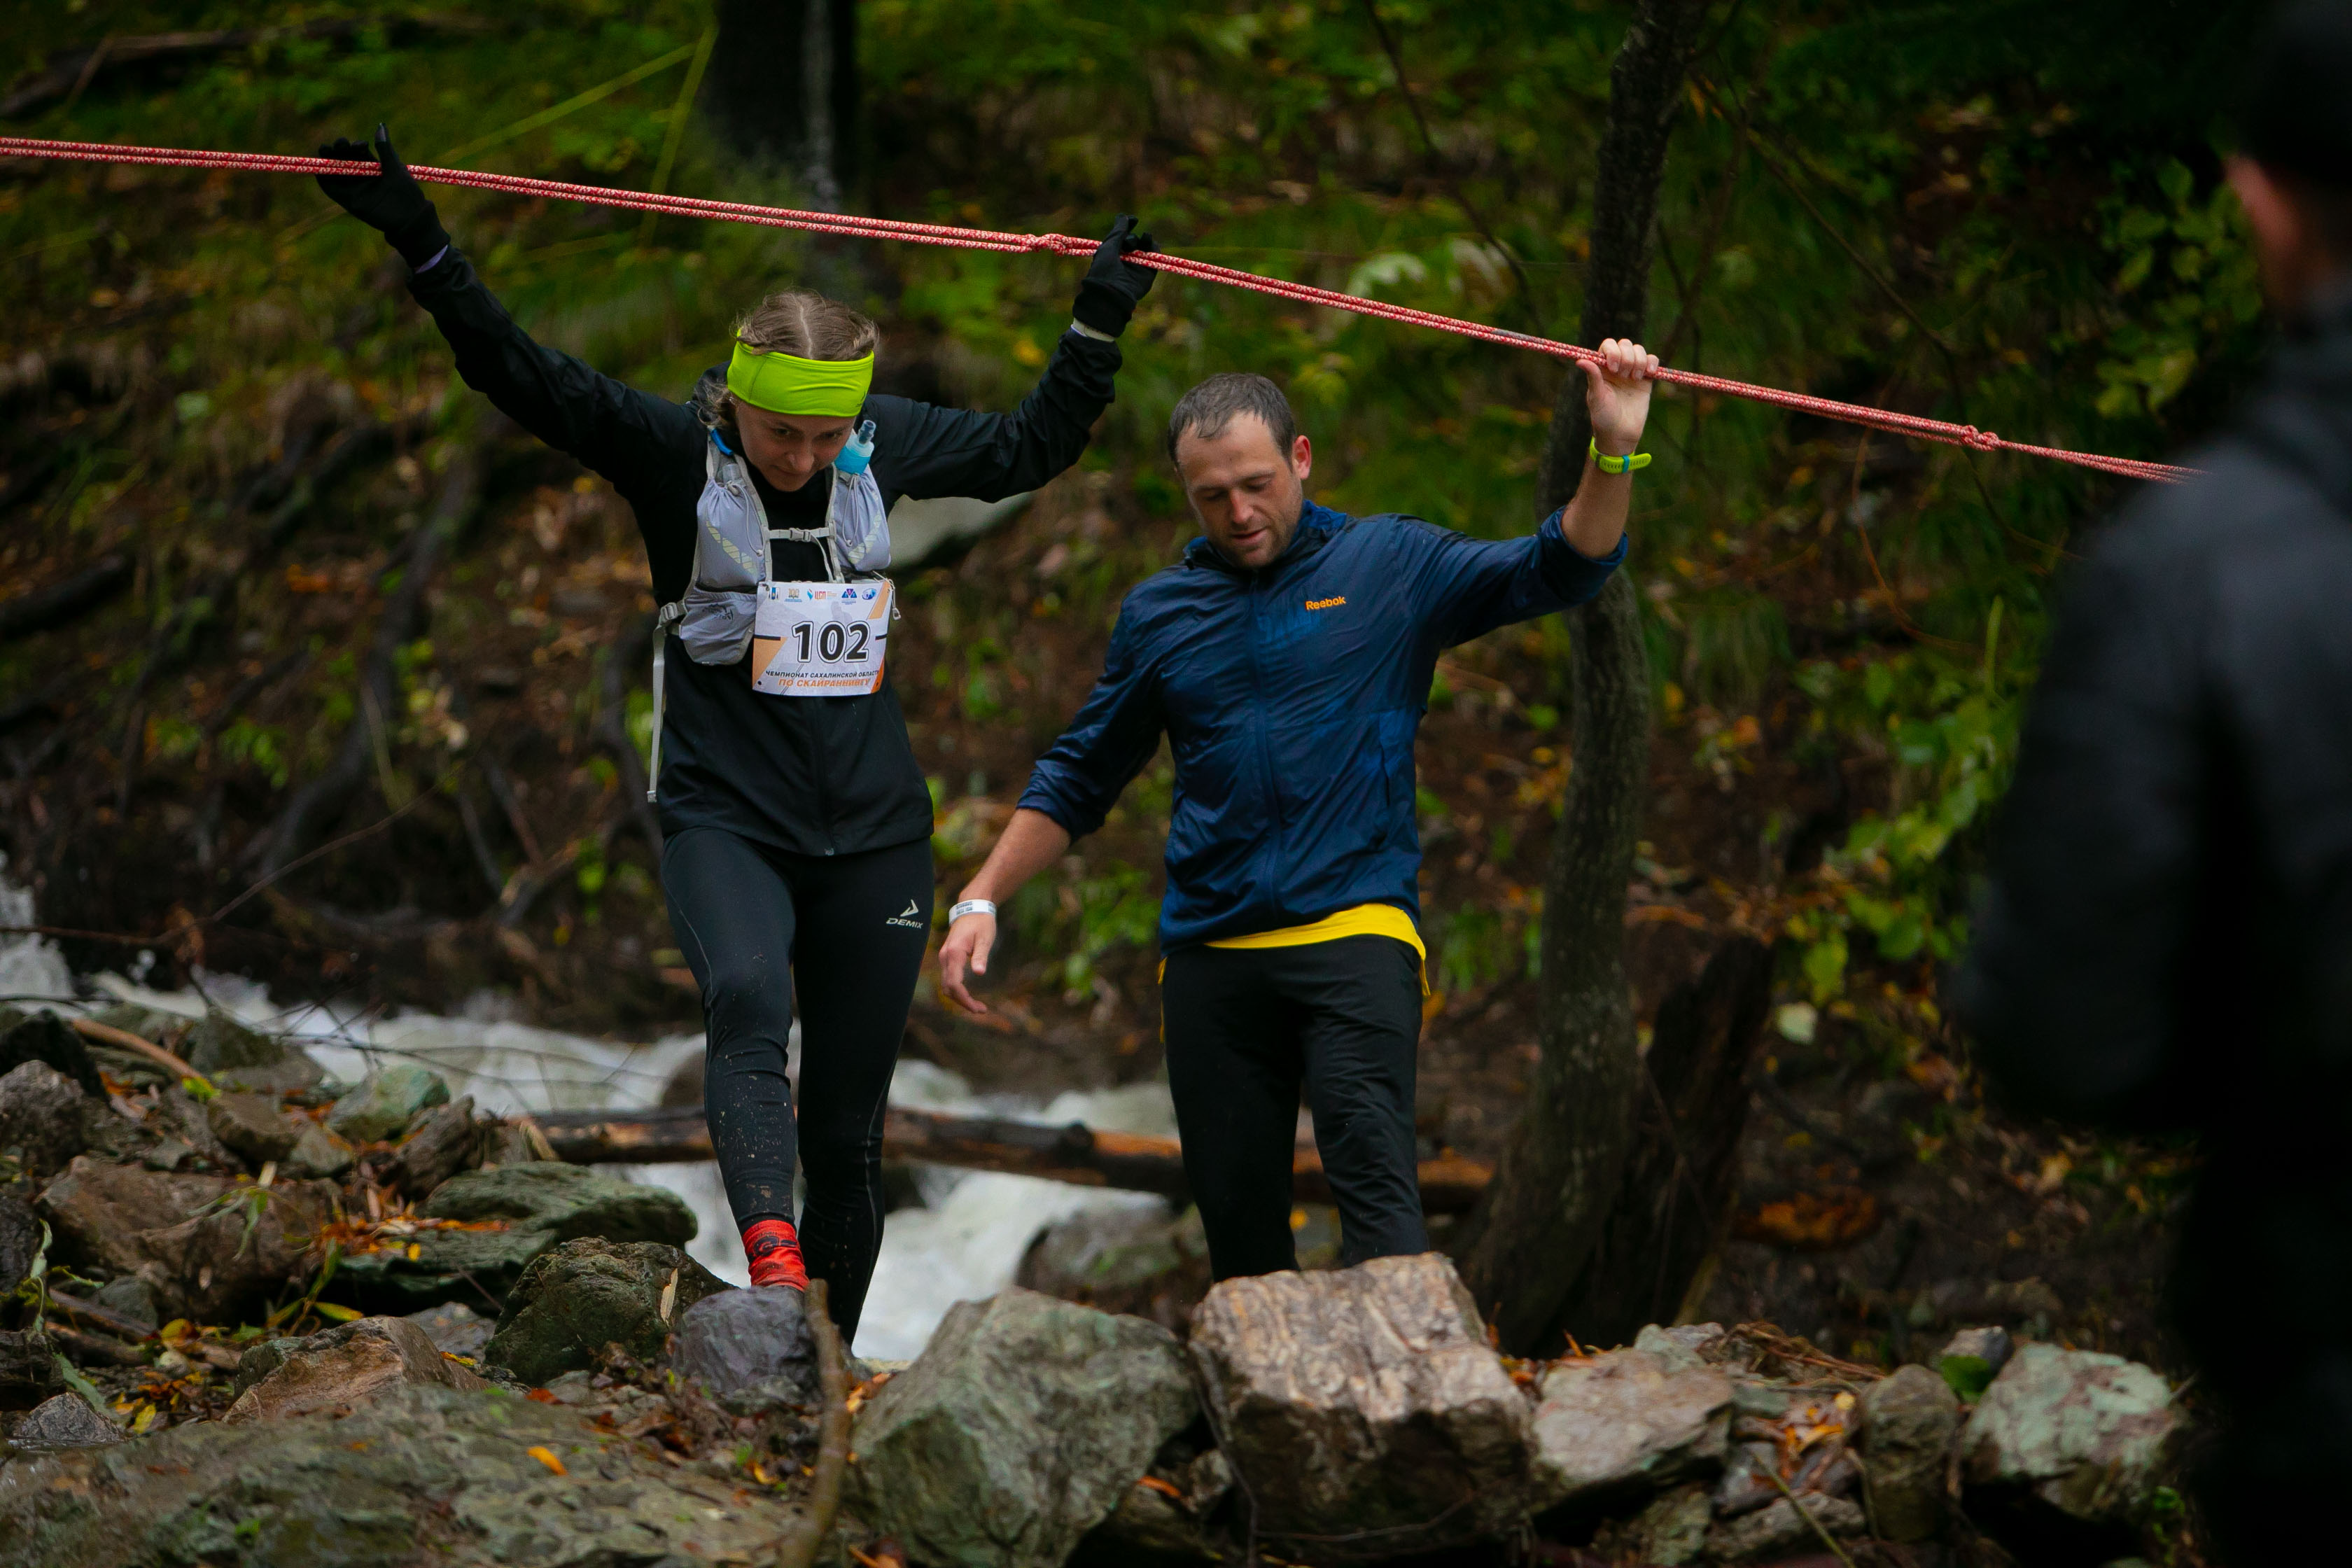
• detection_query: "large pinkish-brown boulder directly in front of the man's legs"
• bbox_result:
[1193,1253,1531,1556]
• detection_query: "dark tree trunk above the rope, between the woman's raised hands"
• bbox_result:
[706,0,858,211]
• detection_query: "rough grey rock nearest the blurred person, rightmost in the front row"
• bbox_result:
[1959,1345,2178,1523]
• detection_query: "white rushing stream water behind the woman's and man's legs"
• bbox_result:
[0,879,1176,1359]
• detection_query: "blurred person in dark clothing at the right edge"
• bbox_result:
[1959,0,2352,1568]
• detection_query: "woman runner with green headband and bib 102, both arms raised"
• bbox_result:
[318,125,1155,1340]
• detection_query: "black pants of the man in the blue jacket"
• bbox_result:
[1159,936,1430,1279]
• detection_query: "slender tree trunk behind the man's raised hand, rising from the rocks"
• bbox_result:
[1458,0,1705,1354]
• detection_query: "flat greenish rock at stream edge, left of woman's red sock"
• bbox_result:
[336,1161,694,1314]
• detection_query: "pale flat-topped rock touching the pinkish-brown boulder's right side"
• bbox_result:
[1534,1350,1731,1507]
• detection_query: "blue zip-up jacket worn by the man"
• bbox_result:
[1021,500,1625,952]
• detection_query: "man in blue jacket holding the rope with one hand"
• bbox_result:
[941,339,1658,1279]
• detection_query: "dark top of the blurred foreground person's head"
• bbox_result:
[2236,0,2352,258]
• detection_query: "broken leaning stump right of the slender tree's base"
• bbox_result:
[1550,936,1771,1345]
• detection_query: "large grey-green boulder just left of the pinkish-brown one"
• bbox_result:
[849,1291,1200,1568]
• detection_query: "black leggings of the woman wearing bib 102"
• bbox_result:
[661,827,932,1340]
